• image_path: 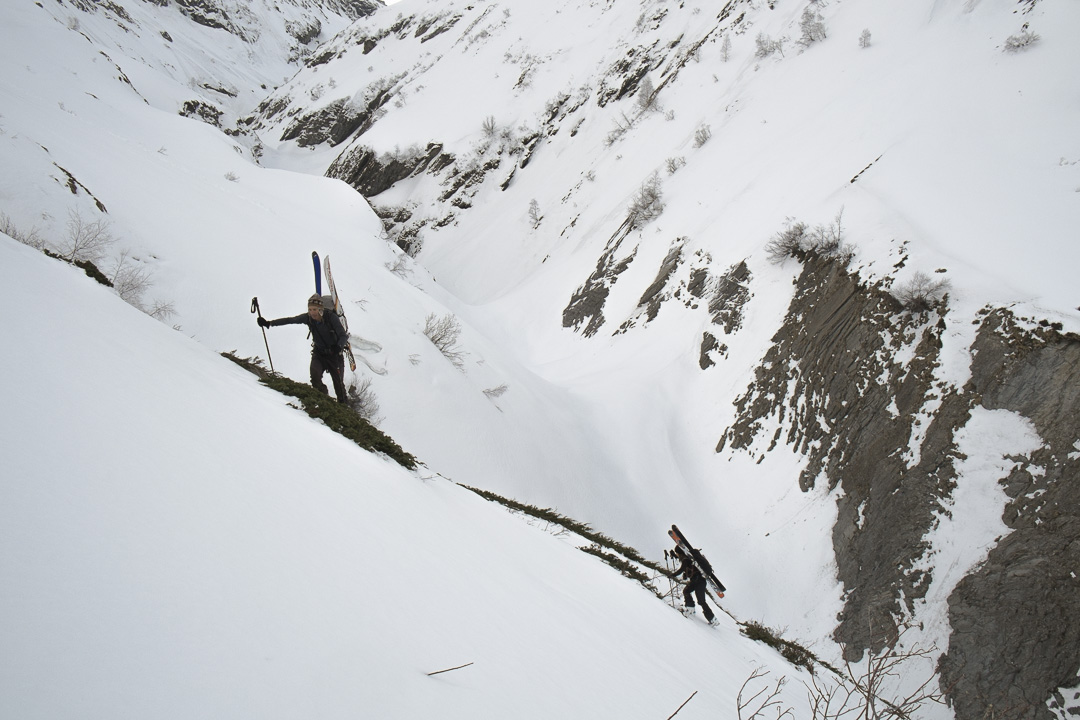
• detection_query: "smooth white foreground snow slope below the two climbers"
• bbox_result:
[0,236,812,720]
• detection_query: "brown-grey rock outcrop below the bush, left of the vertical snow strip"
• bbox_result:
[717,255,954,660]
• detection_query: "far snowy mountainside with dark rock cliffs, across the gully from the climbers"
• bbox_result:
[255,1,1080,718]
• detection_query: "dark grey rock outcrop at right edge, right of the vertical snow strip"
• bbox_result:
[941,310,1080,720]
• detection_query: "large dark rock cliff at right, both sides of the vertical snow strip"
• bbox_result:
[717,256,1080,720]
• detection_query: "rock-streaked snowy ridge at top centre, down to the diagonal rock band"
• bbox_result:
[243,0,752,255]
